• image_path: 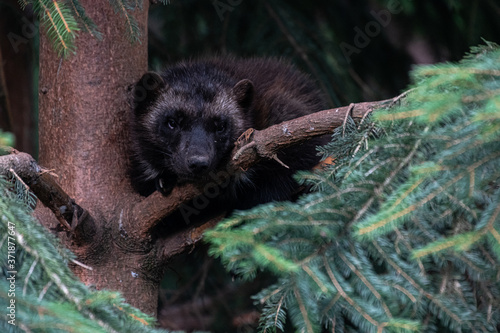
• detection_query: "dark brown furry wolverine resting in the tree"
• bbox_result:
[130,57,326,209]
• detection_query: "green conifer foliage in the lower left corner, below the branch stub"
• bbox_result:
[0,132,169,333]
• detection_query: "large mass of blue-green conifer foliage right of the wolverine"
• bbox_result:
[207,43,500,332]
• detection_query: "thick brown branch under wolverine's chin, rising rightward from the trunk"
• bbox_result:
[130,99,394,238]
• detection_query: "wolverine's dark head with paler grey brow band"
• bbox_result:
[133,64,253,191]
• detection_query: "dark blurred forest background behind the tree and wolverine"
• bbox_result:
[0,0,500,332]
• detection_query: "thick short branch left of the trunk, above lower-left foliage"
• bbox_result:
[0,149,95,243]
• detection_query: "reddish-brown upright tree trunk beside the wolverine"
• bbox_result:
[37,0,161,315]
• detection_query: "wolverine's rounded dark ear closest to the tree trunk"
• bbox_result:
[132,72,166,114]
